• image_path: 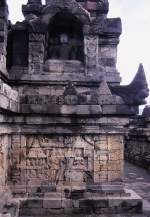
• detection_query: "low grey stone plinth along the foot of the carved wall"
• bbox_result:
[19,190,142,217]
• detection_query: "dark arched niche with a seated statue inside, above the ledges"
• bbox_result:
[45,10,84,62]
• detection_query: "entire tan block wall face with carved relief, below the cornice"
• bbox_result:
[7,135,123,192]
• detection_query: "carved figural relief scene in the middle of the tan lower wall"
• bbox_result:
[27,136,91,188]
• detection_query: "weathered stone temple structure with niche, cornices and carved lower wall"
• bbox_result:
[0,0,148,216]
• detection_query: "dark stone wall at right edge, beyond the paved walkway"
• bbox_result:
[125,106,150,170]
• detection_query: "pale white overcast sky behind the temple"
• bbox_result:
[7,0,150,103]
